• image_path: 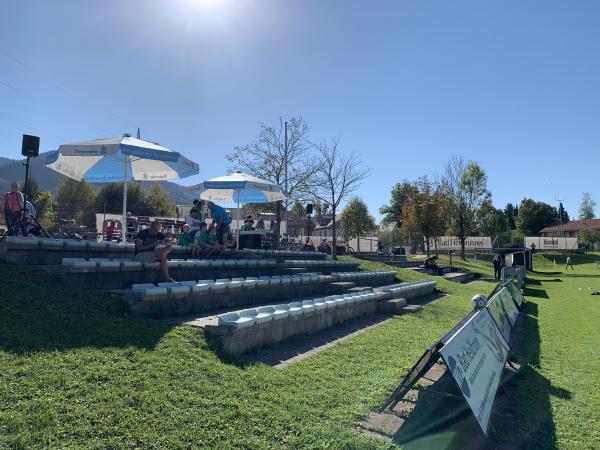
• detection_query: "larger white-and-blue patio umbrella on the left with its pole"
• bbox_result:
[46,134,200,233]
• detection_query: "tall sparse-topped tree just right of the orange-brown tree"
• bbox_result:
[440,155,490,259]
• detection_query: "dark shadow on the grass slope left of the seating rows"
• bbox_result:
[0,264,174,353]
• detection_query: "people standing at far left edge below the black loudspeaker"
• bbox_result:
[0,182,41,238]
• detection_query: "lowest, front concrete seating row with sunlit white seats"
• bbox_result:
[205,291,387,354]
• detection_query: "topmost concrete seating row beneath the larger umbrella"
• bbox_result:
[0,236,253,265]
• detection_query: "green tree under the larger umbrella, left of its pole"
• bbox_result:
[56,178,96,226]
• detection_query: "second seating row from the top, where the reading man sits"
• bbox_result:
[60,258,368,289]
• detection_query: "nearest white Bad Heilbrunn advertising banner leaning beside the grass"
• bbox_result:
[440,308,512,436]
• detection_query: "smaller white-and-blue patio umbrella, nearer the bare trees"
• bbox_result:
[192,171,287,249]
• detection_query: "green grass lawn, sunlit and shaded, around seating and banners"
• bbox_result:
[0,256,600,449]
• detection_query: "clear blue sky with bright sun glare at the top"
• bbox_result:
[0,0,600,221]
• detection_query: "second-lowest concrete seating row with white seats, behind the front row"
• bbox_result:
[124,273,394,317]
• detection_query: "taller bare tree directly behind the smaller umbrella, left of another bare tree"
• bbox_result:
[225,117,316,232]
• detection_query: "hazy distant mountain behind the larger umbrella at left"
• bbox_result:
[0,153,195,205]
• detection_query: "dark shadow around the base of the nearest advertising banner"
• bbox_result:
[386,302,572,450]
